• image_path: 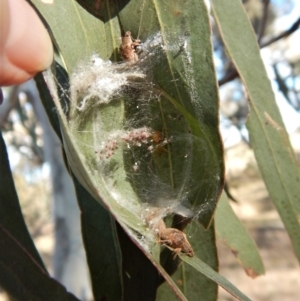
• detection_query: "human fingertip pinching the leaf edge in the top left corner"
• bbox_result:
[0,0,53,86]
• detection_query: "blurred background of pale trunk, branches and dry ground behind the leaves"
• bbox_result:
[0,0,300,301]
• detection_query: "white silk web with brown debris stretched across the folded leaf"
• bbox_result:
[70,32,214,256]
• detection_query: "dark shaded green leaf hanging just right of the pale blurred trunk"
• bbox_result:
[73,177,123,300]
